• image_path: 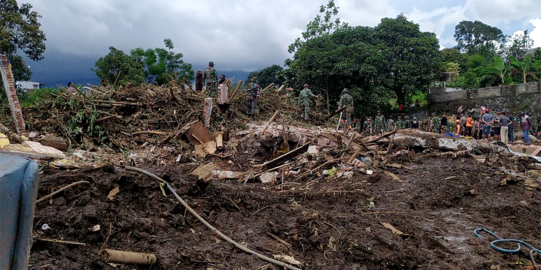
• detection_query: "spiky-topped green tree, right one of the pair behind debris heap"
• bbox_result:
[130,39,194,85]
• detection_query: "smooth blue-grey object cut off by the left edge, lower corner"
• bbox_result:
[0,153,39,269]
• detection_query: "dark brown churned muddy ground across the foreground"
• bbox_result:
[30,154,541,270]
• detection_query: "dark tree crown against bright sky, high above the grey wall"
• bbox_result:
[454,21,506,57]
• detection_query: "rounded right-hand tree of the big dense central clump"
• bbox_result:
[374,14,441,104]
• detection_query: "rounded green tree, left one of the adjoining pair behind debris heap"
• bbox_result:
[91,46,145,85]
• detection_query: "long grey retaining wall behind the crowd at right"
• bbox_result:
[429,83,541,114]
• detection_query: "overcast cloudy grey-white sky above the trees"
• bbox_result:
[19,0,541,84]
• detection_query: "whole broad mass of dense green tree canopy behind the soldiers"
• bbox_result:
[285,7,441,115]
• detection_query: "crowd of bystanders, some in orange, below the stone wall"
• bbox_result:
[427,106,541,143]
